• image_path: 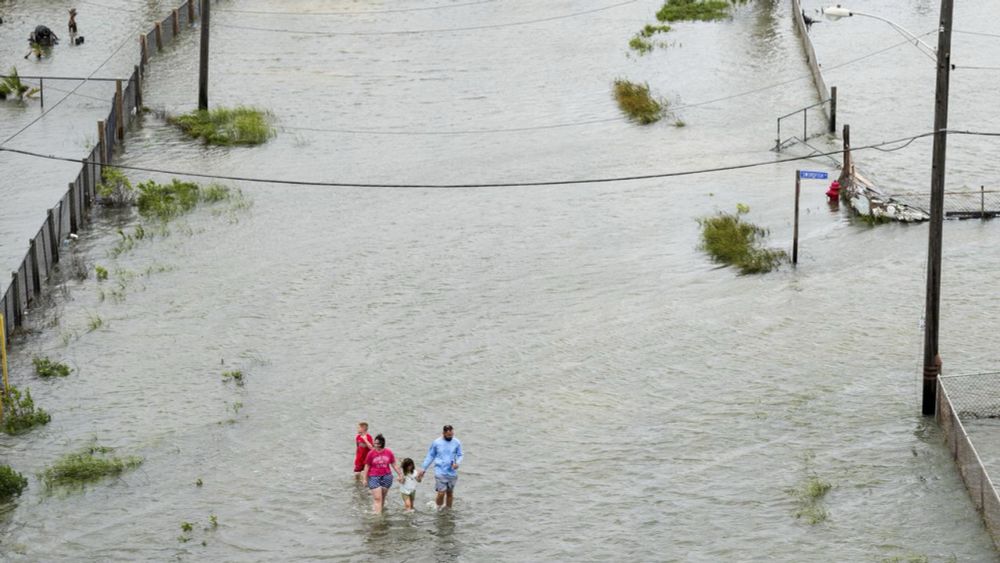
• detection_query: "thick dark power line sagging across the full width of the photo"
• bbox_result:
[7,130,1000,189]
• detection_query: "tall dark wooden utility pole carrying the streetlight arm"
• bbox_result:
[923,0,954,415]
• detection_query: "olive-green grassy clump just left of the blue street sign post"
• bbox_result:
[698,204,788,274]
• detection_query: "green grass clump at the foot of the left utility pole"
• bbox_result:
[168,106,274,146]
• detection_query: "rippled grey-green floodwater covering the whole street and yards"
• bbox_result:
[0,0,1000,561]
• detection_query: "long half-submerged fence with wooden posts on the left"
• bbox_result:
[0,0,201,340]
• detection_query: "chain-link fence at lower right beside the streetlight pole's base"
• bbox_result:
[937,374,1000,549]
